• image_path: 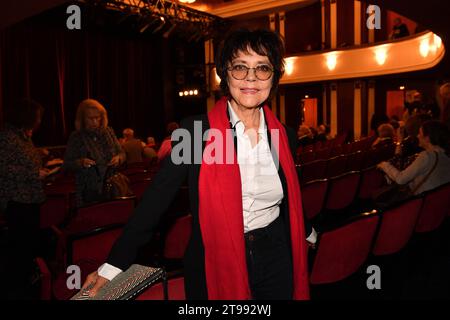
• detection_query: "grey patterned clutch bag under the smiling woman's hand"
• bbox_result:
[70,264,167,300]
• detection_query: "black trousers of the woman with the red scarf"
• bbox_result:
[245,217,293,300]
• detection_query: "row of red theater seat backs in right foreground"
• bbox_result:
[310,184,450,285]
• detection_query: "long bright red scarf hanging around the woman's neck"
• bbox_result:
[199,98,309,300]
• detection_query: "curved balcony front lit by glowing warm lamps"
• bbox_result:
[280,31,445,84]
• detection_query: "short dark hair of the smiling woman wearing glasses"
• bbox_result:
[216,29,285,100]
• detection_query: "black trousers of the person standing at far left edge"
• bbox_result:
[1,201,41,299]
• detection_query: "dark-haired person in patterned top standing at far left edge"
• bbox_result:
[0,99,50,299]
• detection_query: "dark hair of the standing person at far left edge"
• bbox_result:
[5,98,44,129]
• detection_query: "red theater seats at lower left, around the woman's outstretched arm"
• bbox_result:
[37,159,191,300]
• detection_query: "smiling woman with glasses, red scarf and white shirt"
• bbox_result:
[84,30,315,299]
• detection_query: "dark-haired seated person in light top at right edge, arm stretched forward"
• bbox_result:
[378,120,450,194]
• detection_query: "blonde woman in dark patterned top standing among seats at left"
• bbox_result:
[64,99,126,207]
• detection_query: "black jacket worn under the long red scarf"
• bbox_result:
[107,115,311,299]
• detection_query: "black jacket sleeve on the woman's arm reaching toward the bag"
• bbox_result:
[107,117,192,270]
